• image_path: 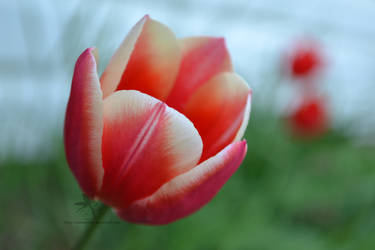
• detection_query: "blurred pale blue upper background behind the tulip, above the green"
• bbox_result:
[0,0,375,162]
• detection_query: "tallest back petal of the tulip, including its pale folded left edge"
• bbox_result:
[101,16,181,100]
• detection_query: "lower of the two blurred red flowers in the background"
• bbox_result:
[289,97,328,138]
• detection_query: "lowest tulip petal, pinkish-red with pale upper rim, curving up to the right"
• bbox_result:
[117,141,247,225]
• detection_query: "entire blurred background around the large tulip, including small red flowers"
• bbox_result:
[0,0,375,250]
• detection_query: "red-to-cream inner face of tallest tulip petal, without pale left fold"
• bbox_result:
[117,16,181,101]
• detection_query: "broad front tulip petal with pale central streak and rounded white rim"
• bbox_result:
[99,90,202,208]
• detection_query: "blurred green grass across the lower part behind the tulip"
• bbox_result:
[0,112,375,250]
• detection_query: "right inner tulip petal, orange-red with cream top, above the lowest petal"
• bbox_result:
[183,72,251,161]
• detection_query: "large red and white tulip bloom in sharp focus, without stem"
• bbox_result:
[64,16,251,225]
